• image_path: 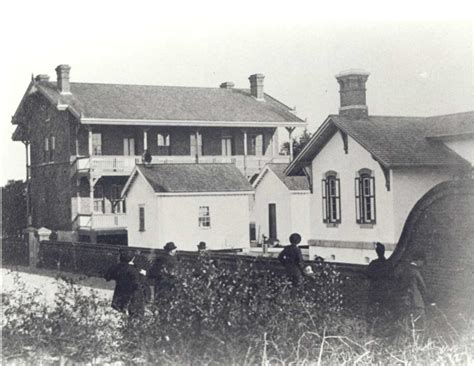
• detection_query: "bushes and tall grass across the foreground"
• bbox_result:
[2,257,474,365]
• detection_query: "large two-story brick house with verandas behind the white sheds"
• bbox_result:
[12,65,306,242]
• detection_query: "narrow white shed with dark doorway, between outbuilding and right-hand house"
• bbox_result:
[253,164,310,244]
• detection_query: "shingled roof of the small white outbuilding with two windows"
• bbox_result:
[123,164,253,194]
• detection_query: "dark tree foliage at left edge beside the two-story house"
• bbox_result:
[1,180,27,238]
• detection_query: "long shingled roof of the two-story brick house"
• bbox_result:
[13,81,306,127]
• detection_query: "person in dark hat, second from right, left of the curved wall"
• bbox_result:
[366,242,392,327]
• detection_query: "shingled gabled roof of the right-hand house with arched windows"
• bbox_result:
[286,112,474,174]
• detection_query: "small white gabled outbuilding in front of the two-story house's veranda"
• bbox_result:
[122,164,253,250]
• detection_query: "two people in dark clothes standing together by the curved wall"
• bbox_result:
[367,242,435,331]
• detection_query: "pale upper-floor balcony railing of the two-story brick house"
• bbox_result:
[75,155,290,177]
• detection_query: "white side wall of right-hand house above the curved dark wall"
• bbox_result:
[392,167,456,237]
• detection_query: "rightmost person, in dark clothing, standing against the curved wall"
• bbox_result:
[401,252,435,330]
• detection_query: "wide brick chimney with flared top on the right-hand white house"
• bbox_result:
[336,69,370,119]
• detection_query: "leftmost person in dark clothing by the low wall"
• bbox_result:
[104,251,140,313]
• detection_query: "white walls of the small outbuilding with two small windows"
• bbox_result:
[127,175,250,250]
